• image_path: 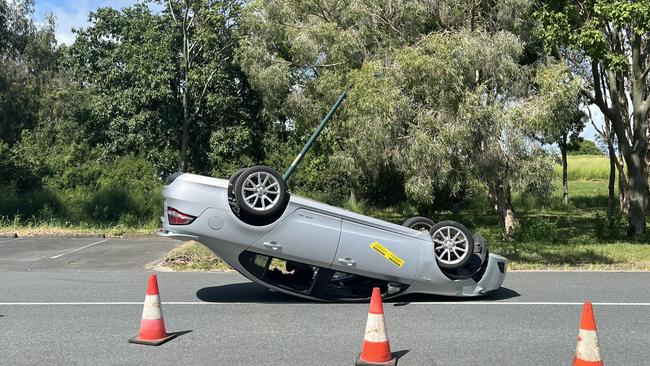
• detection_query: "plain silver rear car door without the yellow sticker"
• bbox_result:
[251,209,341,268]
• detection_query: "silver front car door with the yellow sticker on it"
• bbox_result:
[331,221,421,284]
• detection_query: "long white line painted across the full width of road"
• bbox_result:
[0,301,650,306]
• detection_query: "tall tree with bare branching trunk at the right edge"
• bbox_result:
[538,0,650,236]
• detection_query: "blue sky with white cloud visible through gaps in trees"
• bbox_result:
[34,0,602,140]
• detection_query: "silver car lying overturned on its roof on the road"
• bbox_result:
[159,166,507,301]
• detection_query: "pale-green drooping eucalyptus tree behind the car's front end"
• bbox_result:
[348,30,553,236]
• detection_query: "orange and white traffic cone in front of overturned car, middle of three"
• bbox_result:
[354,287,397,366]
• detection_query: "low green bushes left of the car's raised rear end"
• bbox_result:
[0,156,162,227]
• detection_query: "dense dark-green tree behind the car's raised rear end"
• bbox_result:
[67,1,264,174]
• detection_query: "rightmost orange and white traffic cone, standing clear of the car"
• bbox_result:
[573,301,604,366]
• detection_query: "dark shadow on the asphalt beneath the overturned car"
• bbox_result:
[196,282,521,306]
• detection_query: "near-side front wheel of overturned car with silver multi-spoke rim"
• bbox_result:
[430,221,474,268]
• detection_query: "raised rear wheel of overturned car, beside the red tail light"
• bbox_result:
[234,166,289,217]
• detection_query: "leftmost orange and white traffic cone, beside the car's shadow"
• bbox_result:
[129,273,176,346]
